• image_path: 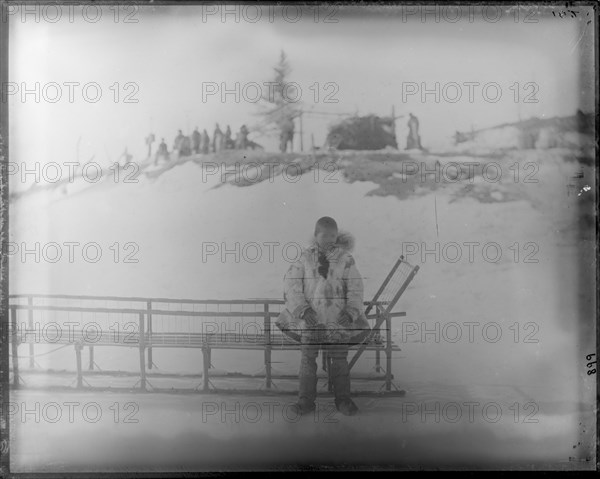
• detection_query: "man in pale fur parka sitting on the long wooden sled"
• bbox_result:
[276,216,370,415]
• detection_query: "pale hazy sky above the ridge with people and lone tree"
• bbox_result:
[5,5,594,164]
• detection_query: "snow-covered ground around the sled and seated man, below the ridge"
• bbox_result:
[10,150,596,471]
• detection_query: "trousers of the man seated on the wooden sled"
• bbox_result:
[298,330,350,406]
